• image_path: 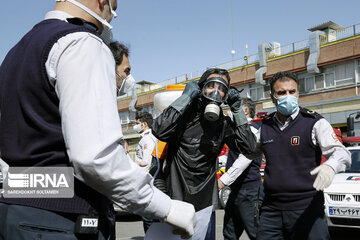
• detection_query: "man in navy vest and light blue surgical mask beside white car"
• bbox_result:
[256,72,350,240]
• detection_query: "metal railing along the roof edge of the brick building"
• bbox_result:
[119,24,360,97]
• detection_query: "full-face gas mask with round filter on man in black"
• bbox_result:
[201,75,229,121]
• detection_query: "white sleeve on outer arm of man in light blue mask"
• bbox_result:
[313,118,351,173]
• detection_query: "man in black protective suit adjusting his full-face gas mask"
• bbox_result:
[153,68,256,238]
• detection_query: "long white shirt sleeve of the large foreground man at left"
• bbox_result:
[46,32,171,219]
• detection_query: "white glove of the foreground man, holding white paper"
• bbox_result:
[164,200,196,239]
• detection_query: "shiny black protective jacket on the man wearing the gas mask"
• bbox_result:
[152,100,256,211]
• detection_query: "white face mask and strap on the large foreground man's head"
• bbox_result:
[56,0,117,44]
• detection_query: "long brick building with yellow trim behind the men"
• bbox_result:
[118,22,360,156]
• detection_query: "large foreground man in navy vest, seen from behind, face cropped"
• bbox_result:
[0,0,195,240]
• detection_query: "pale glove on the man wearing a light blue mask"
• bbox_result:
[310,164,335,191]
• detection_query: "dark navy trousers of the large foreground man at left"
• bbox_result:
[0,203,115,240]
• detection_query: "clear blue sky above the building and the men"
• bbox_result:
[0,0,360,82]
